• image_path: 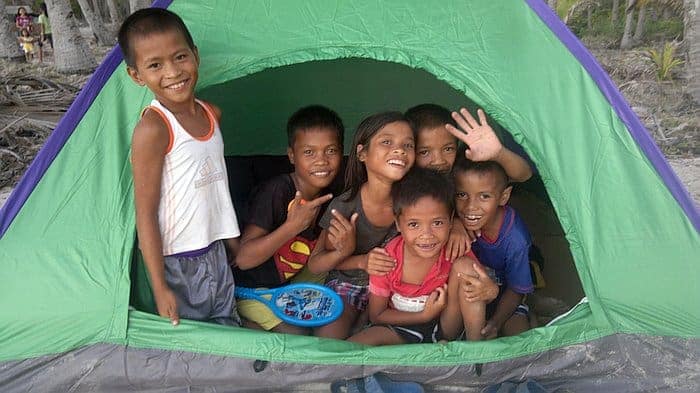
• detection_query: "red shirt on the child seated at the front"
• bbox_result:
[369,235,476,306]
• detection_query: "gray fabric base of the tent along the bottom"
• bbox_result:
[0,334,700,393]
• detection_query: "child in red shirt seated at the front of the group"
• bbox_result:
[348,168,498,345]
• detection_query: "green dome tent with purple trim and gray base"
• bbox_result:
[0,0,700,392]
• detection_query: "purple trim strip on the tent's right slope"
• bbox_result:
[526,0,700,231]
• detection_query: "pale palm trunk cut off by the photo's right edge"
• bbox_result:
[683,0,700,104]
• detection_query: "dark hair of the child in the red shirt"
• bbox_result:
[391,167,455,217]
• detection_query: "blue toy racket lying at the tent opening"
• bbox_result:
[235,283,343,327]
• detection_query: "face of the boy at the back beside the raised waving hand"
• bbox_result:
[416,126,457,173]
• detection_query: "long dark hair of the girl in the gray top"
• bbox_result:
[345,112,411,201]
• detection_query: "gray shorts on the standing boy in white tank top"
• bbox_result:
[165,240,241,326]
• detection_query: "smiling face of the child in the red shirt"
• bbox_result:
[396,196,452,262]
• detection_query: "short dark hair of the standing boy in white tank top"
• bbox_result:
[118,8,195,67]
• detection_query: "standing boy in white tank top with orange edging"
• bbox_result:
[119,8,240,325]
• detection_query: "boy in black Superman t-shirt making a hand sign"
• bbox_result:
[233,105,344,334]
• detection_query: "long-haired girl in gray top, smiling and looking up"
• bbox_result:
[308,112,415,339]
